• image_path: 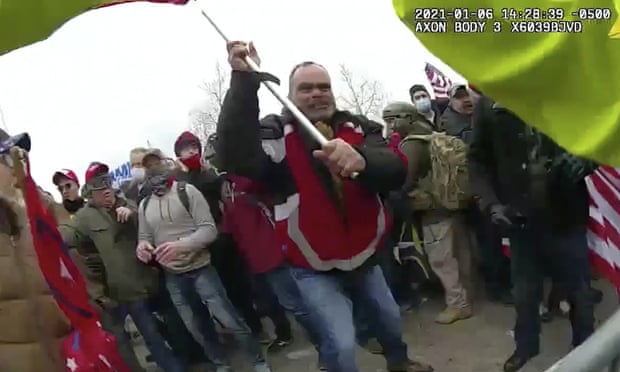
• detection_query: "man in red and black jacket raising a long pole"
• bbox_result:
[216,42,433,372]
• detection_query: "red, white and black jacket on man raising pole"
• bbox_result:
[216,71,407,271]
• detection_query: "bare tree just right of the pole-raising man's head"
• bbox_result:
[338,64,387,119]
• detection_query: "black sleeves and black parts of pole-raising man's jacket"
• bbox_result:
[216,71,407,206]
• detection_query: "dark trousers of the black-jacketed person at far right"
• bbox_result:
[509,220,594,355]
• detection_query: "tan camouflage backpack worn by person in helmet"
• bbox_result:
[401,132,471,210]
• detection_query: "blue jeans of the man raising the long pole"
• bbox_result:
[291,265,408,372]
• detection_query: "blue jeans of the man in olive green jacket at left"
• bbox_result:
[123,300,185,372]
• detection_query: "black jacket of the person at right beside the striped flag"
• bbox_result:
[469,97,589,229]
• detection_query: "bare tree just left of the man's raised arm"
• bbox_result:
[189,61,230,143]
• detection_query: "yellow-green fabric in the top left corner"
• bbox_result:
[0,0,113,55]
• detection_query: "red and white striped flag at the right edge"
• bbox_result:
[586,166,620,293]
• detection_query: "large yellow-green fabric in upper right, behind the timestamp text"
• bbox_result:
[393,0,620,166]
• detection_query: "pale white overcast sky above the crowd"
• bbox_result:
[0,0,458,196]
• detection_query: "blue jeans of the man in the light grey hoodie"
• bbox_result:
[166,265,265,367]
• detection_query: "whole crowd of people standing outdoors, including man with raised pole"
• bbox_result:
[0,42,601,372]
